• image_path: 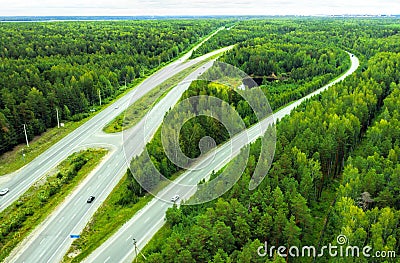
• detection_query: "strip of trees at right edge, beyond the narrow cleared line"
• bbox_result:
[327,82,400,260]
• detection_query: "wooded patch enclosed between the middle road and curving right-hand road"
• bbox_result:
[131,21,350,194]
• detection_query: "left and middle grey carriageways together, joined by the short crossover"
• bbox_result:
[1,33,232,262]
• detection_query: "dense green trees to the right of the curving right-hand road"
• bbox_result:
[138,20,400,262]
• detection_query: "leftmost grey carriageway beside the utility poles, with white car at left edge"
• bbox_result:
[0,28,224,212]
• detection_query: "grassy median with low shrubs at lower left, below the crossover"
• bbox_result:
[0,149,107,261]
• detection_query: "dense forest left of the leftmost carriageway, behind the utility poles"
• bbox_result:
[0,19,224,154]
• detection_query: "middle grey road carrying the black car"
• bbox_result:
[9,54,231,262]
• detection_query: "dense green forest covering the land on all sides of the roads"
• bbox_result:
[0,17,400,263]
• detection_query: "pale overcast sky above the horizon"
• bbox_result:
[0,0,400,16]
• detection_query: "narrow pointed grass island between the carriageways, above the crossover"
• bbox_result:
[103,59,209,133]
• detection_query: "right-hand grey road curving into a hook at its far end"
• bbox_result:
[84,53,359,263]
